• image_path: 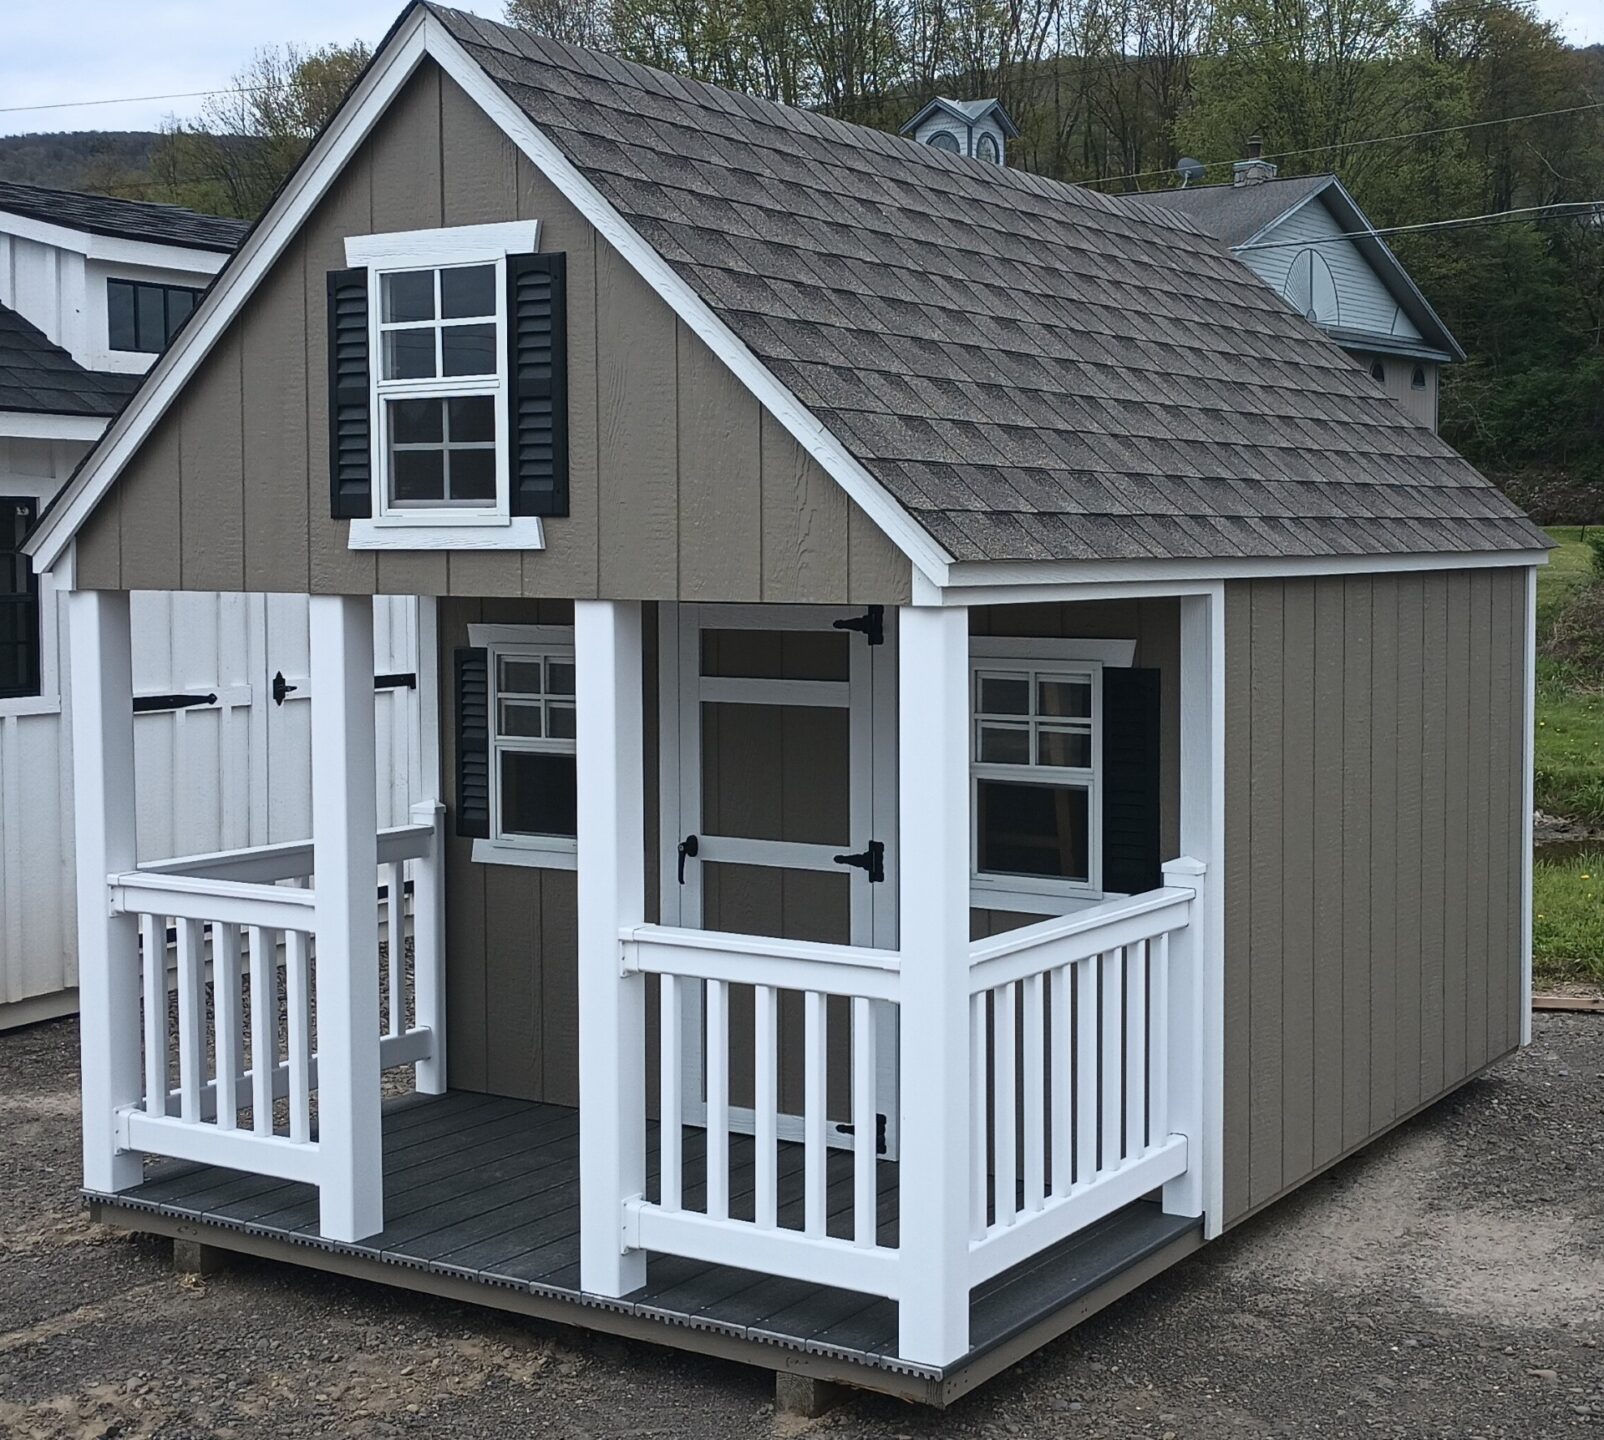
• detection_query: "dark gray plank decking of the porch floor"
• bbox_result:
[90,1092,1200,1400]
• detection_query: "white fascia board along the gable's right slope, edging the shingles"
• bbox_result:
[427,16,951,584]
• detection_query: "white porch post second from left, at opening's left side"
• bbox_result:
[310,595,385,1240]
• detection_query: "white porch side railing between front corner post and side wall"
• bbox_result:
[969,876,1200,1284]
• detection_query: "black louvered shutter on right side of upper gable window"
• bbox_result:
[507,252,568,515]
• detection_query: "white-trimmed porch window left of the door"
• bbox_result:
[470,625,577,869]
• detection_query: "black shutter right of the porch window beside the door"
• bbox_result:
[1102,665,1163,895]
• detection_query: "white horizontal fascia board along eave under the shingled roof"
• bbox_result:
[936,550,1548,605]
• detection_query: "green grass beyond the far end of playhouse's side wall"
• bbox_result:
[1532,526,1604,983]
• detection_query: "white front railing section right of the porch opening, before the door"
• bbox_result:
[621,925,900,1296]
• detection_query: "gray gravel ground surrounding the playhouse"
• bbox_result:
[0,1015,1604,1440]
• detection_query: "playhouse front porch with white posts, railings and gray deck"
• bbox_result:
[71,592,1219,1387]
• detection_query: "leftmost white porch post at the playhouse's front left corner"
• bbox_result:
[66,590,144,1191]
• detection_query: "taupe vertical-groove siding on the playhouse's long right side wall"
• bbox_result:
[1224,569,1532,1224]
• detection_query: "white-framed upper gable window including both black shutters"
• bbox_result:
[338,221,568,550]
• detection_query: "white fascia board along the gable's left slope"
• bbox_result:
[22,10,427,572]
